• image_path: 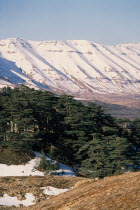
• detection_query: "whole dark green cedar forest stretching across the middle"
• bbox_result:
[0,86,140,178]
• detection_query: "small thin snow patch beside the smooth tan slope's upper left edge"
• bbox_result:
[41,186,69,195]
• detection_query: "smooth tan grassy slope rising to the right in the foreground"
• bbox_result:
[24,172,140,210]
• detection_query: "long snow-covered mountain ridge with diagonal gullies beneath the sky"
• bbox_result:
[0,38,140,98]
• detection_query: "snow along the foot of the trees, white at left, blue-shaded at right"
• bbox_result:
[0,152,76,176]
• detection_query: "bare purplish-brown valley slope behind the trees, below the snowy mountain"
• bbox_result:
[79,94,140,120]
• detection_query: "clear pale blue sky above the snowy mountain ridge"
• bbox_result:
[0,0,140,45]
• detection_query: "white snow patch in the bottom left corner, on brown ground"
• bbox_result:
[0,193,35,207]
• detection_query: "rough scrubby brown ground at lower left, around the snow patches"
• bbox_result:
[0,175,85,210]
